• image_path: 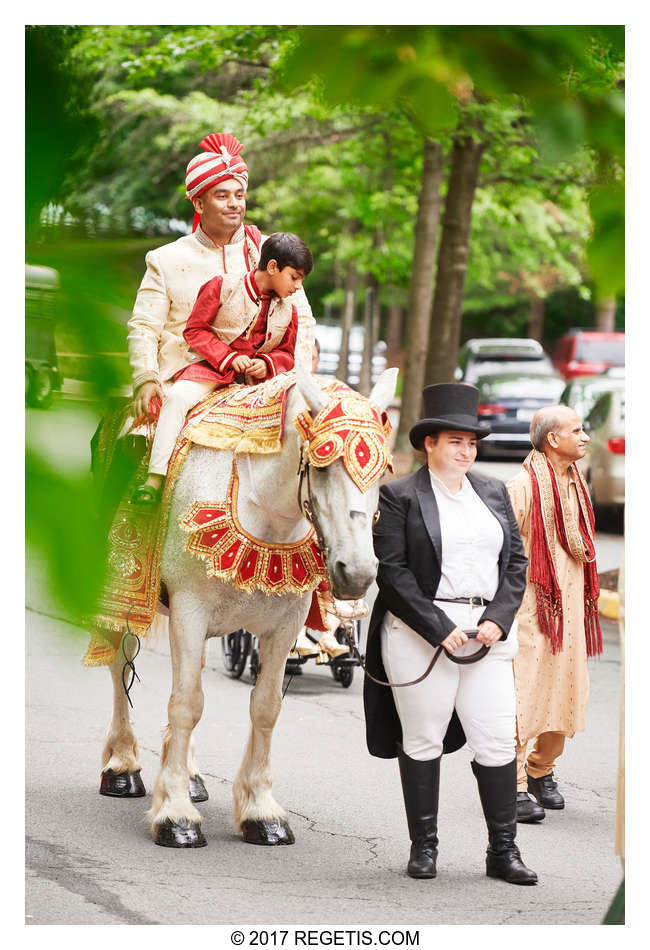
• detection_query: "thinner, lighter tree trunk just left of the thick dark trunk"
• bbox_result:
[395,139,445,452]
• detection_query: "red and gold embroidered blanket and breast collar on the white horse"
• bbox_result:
[82,373,325,666]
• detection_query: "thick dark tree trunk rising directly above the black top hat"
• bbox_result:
[425,132,486,384]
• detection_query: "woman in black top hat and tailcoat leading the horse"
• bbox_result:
[364,383,537,884]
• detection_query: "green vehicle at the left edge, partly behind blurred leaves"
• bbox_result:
[25,264,61,409]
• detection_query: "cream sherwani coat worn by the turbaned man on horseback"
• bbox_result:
[127,225,315,388]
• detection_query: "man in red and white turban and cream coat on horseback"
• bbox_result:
[128,133,315,416]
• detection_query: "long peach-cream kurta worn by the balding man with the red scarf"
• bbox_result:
[507,470,589,745]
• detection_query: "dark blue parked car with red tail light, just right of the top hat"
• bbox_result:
[476,373,564,458]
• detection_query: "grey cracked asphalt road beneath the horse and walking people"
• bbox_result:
[26,407,622,928]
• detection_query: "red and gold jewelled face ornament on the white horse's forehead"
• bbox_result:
[294,383,393,492]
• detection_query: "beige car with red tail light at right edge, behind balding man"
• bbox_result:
[580,389,625,508]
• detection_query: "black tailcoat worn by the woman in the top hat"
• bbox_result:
[363,465,528,759]
